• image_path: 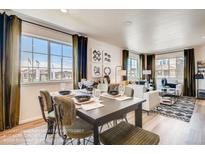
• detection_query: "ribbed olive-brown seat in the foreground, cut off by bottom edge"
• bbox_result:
[100,121,160,145]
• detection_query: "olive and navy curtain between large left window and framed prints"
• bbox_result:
[73,35,88,89]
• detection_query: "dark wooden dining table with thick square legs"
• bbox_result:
[52,89,146,145]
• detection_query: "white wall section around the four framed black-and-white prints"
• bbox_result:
[87,38,122,82]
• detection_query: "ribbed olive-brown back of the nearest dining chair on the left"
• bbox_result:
[54,96,76,136]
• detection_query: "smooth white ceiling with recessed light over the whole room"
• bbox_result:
[12,10,205,53]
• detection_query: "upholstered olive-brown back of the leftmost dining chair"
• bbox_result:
[40,90,53,112]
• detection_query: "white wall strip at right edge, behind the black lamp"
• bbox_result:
[194,44,205,89]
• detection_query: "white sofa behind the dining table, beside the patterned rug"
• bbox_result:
[128,84,160,112]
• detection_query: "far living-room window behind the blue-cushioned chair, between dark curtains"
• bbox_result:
[155,53,184,88]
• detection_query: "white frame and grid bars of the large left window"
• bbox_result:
[20,33,73,85]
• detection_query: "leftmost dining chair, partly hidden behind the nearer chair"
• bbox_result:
[38,90,56,144]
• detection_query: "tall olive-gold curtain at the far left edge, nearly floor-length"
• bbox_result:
[0,13,21,131]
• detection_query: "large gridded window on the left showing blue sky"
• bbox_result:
[21,35,72,83]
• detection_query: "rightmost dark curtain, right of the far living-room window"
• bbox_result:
[184,49,196,97]
